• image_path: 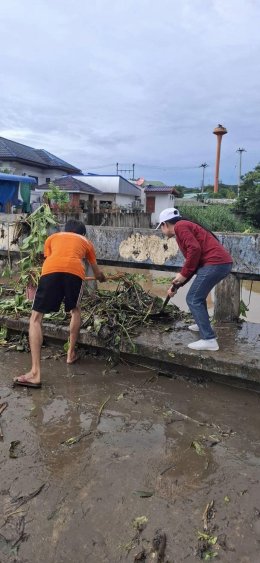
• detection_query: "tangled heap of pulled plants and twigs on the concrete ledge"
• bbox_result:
[0,274,187,348]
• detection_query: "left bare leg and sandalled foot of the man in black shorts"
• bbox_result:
[16,311,43,383]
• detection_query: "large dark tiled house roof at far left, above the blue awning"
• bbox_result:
[0,137,80,173]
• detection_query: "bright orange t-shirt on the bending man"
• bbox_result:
[42,232,96,280]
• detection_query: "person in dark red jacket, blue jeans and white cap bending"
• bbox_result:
[157,207,233,351]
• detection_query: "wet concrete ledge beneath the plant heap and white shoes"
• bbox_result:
[0,316,260,383]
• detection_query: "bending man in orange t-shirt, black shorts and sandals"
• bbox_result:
[14,221,106,388]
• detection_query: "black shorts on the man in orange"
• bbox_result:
[32,272,83,313]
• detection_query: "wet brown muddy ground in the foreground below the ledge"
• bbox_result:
[0,347,260,563]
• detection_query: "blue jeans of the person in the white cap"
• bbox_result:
[186,264,232,340]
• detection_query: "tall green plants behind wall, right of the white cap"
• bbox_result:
[176,204,254,233]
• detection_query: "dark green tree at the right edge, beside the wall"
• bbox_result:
[235,164,260,227]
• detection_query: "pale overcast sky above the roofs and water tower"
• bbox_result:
[0,0,260,186]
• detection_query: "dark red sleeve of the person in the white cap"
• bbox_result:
[175,223,201,278]
